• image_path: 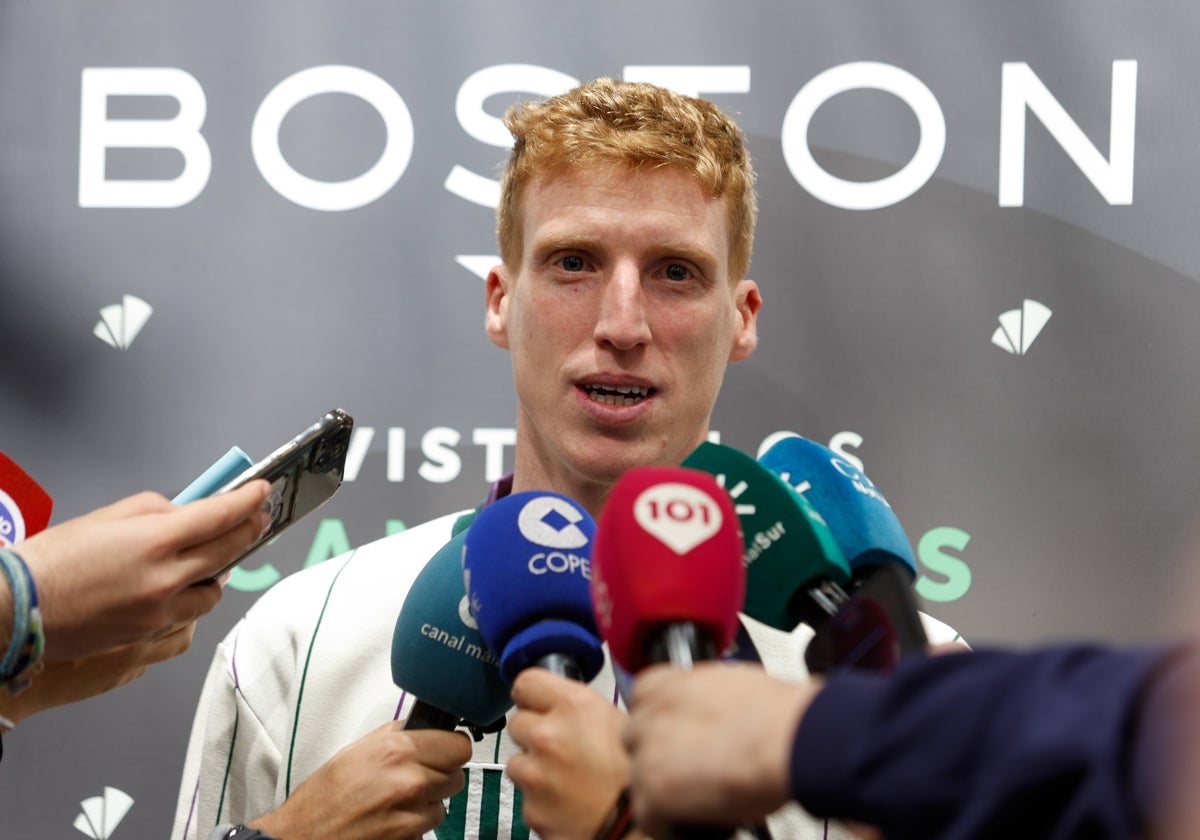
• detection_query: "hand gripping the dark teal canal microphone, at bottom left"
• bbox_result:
[251,721,472,840]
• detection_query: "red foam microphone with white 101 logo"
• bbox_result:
[592,467,745,672]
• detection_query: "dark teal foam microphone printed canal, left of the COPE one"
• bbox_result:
[391,530,512,731]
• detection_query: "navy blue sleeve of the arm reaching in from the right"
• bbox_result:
[792,646,1195,840]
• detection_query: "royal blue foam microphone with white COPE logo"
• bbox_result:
[462,491,604,684]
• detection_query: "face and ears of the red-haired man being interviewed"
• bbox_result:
[487,164,761,492]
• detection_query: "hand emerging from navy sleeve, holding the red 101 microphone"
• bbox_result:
[624,662,820,836]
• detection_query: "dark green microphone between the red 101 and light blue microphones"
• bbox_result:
[683,443,850,631]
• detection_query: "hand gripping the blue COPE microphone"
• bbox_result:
[506,668,629,840]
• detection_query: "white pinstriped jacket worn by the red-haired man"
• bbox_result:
[172,511,956,840]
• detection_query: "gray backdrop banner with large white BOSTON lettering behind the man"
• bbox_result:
[0,0,1200,840]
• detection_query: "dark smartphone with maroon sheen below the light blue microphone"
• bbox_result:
[804,564,929,673]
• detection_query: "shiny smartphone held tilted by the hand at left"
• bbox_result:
[207,408,354,577]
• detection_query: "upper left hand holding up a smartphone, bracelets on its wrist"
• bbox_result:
[13,480,270,661]
